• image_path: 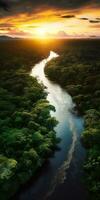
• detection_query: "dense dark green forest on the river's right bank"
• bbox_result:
[45,40,100,200]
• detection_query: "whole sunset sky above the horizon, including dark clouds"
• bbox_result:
[0,0,100,39]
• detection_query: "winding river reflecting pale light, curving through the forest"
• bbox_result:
[17,51,86,200]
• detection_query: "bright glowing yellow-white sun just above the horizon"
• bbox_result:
[36,27,47,39]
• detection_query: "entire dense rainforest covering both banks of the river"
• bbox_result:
[0,39,100,200]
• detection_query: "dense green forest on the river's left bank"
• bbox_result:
[0,40,58,200]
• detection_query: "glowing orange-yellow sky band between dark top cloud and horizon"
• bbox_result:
[0,2,100,38]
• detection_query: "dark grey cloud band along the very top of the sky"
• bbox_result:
[0,0,100,12]
